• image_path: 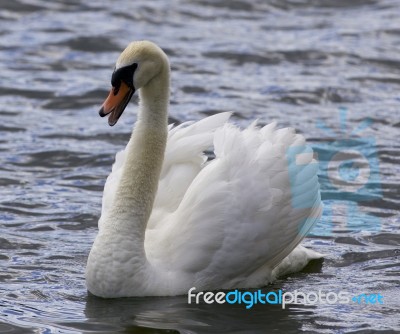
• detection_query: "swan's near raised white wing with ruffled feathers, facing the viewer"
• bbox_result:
[146,124,322,288]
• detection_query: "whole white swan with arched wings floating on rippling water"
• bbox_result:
[85,41,322,298]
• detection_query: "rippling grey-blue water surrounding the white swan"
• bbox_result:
[0,0,400,333]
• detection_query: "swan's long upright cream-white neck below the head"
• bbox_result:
[109,66,169,239]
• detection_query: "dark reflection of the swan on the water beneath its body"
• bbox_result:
[85,290,309,333]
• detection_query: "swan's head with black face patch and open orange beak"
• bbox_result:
[99,41,169,126]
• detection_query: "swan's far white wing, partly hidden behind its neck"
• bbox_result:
[99,112,231,229]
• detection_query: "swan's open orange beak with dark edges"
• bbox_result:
[99,81,135,126]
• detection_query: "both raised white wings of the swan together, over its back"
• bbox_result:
[99,113,322,293]
